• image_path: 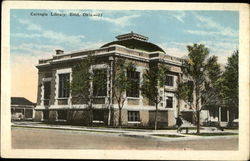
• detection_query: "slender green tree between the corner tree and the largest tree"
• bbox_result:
[141,64,169,130]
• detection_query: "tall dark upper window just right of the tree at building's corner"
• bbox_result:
[126,71,140,97]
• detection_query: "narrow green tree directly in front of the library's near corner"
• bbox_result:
[113,59,135,127]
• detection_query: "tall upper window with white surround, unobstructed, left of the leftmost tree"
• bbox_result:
[59,73,70,98]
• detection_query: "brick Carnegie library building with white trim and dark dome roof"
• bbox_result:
[35,32,232,127]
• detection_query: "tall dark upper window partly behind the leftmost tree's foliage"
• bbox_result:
[93,69,107,96]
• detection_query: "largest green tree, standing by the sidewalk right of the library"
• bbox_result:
[177,44,221,133]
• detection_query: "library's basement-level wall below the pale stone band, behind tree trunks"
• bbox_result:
[35,109,175,127]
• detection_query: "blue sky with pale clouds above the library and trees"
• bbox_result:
[10,9,239,100]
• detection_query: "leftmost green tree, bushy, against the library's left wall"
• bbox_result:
[71,55,106,126]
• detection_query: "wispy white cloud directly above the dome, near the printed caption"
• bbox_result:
[90,15,140,27]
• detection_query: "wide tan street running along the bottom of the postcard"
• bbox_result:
[12,127,238,150]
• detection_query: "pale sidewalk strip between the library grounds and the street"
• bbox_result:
[11,122,238,140]
